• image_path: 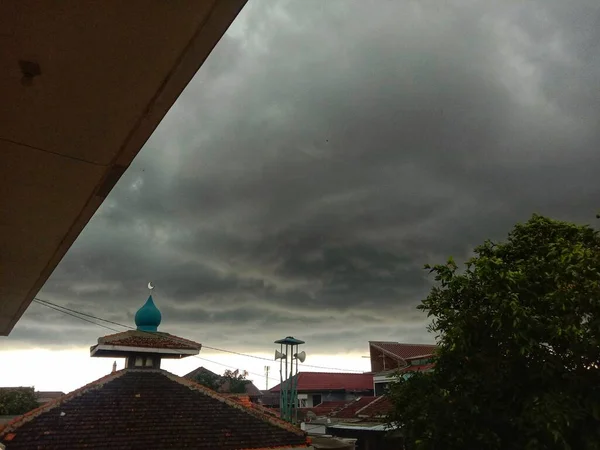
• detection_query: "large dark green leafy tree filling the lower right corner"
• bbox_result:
[389,215,600,450]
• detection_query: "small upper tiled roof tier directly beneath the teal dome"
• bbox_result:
[92,330,202,350]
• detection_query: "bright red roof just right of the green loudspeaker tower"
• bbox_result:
[271,372,373,392]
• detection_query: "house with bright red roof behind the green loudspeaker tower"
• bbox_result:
[270,372,373,408]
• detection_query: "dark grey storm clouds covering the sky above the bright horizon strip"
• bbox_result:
[11,0,600,352]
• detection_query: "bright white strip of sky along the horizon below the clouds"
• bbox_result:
[0,347,370,393]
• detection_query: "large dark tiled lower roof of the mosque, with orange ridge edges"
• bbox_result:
[0,369,308,450]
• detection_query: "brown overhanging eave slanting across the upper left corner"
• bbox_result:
[0,0,246,336]
